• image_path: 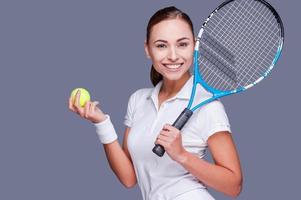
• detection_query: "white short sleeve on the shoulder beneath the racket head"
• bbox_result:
[199,100,231,141]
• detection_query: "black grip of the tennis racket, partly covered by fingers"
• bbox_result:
[152,108,193,157]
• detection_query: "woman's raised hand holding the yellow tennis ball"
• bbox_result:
[69,90,106,123]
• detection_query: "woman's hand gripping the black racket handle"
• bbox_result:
[155,124,186,162]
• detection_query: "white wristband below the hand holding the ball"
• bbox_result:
[94,115,117,144]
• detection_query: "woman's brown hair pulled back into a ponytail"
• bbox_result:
[146,6,193,86]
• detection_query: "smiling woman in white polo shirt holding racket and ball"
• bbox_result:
[69,7,242,200]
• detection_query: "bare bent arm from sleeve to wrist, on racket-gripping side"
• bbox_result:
[179,132,242,197]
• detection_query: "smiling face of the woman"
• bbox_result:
[145,19,194,80]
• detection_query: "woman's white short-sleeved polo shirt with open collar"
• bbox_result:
[124,76,230,200]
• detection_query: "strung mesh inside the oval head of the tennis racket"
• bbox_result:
[198,0,280,90]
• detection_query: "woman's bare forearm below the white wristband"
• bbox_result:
[103,140,136,188]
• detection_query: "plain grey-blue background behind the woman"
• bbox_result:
[0,0,301,200]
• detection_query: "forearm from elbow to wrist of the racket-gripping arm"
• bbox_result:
[178,151,241,197]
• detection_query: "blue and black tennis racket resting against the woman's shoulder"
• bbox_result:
[153,0,284,157]
